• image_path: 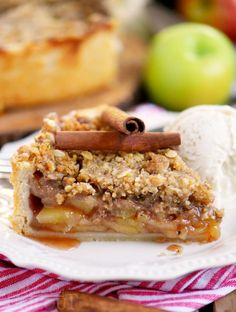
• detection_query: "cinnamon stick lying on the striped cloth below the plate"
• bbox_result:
[57,290,162,312]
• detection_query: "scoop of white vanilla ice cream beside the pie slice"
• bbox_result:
[165,105,236,207]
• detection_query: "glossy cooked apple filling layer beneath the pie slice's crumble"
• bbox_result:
[29,177,221,241]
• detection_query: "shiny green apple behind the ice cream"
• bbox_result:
[144,23,235,110]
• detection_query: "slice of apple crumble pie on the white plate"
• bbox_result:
[11,110,222,242]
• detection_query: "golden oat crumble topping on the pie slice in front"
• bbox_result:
[13,111,217,218]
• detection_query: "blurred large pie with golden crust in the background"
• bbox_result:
[0,1,119,108]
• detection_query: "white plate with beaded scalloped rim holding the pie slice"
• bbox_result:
[0,185,236,281]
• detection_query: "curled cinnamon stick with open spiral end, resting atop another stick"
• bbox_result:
[102,107,145,134]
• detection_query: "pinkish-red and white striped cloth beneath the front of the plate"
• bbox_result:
[0,256,236,312]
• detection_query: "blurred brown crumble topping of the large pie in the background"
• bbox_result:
[0,0,113,50]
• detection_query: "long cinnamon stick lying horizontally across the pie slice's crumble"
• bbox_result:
[55,131,181,152]
